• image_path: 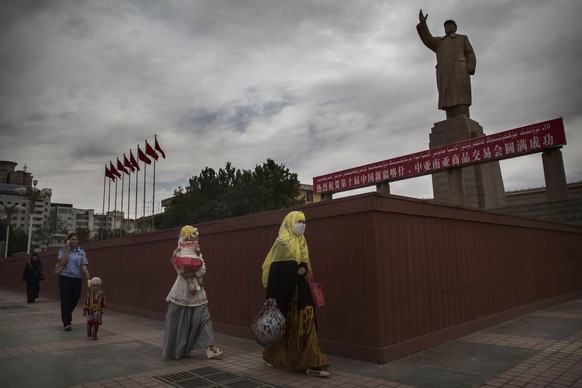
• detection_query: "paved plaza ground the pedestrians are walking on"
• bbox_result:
[0,289,582,388]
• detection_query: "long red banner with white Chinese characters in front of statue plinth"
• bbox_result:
[313,118,566,194]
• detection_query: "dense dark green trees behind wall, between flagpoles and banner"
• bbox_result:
[160,159,302,228]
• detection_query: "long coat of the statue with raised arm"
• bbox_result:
[416,23,477,110]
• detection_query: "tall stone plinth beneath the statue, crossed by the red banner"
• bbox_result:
[429,116,505,209]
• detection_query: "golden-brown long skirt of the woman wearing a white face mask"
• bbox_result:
[263,293,329,371]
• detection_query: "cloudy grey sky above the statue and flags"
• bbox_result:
[0,0,582,216]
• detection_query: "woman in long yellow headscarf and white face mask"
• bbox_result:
[263,211,329,377]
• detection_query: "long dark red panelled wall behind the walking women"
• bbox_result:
[0,193,582,363]
